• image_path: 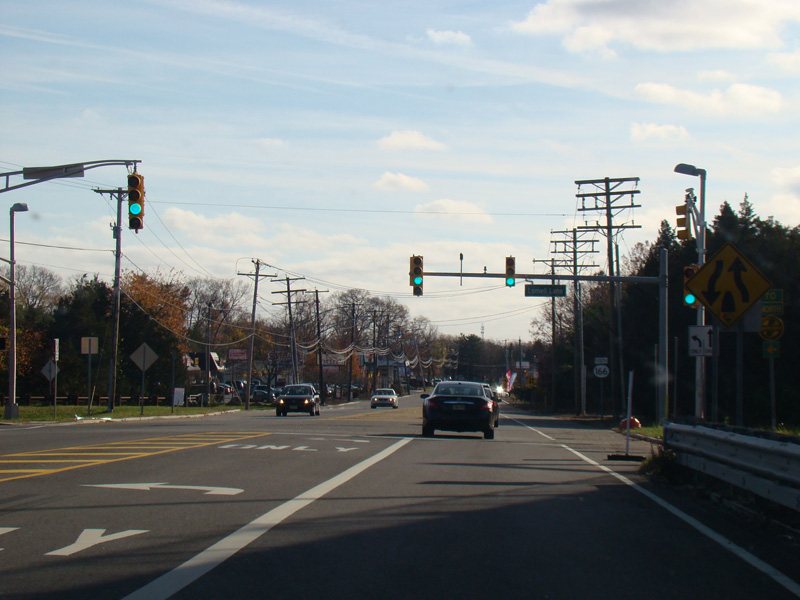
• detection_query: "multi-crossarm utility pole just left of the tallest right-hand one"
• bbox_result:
[550,228,597,415]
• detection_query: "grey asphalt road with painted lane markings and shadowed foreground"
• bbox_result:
[0,396,800,600]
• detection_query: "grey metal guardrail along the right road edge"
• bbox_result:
[664,423,800,512]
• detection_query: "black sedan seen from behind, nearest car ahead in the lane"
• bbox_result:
[422,381,500,440]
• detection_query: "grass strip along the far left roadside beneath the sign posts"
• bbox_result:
[3,404,247,423]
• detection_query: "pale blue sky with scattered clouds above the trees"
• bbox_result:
[0,0,800,341]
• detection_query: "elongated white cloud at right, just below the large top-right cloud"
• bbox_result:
[636,83,782,116]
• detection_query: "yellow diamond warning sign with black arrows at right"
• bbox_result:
[686,244,772,327]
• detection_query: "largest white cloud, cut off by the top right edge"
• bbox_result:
[511,0,800,56]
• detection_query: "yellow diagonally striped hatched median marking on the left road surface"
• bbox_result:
[0,431,270,481]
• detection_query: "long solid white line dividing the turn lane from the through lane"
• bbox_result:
[123,438,412,600]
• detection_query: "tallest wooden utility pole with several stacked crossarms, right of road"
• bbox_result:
[575,177,641,418]
